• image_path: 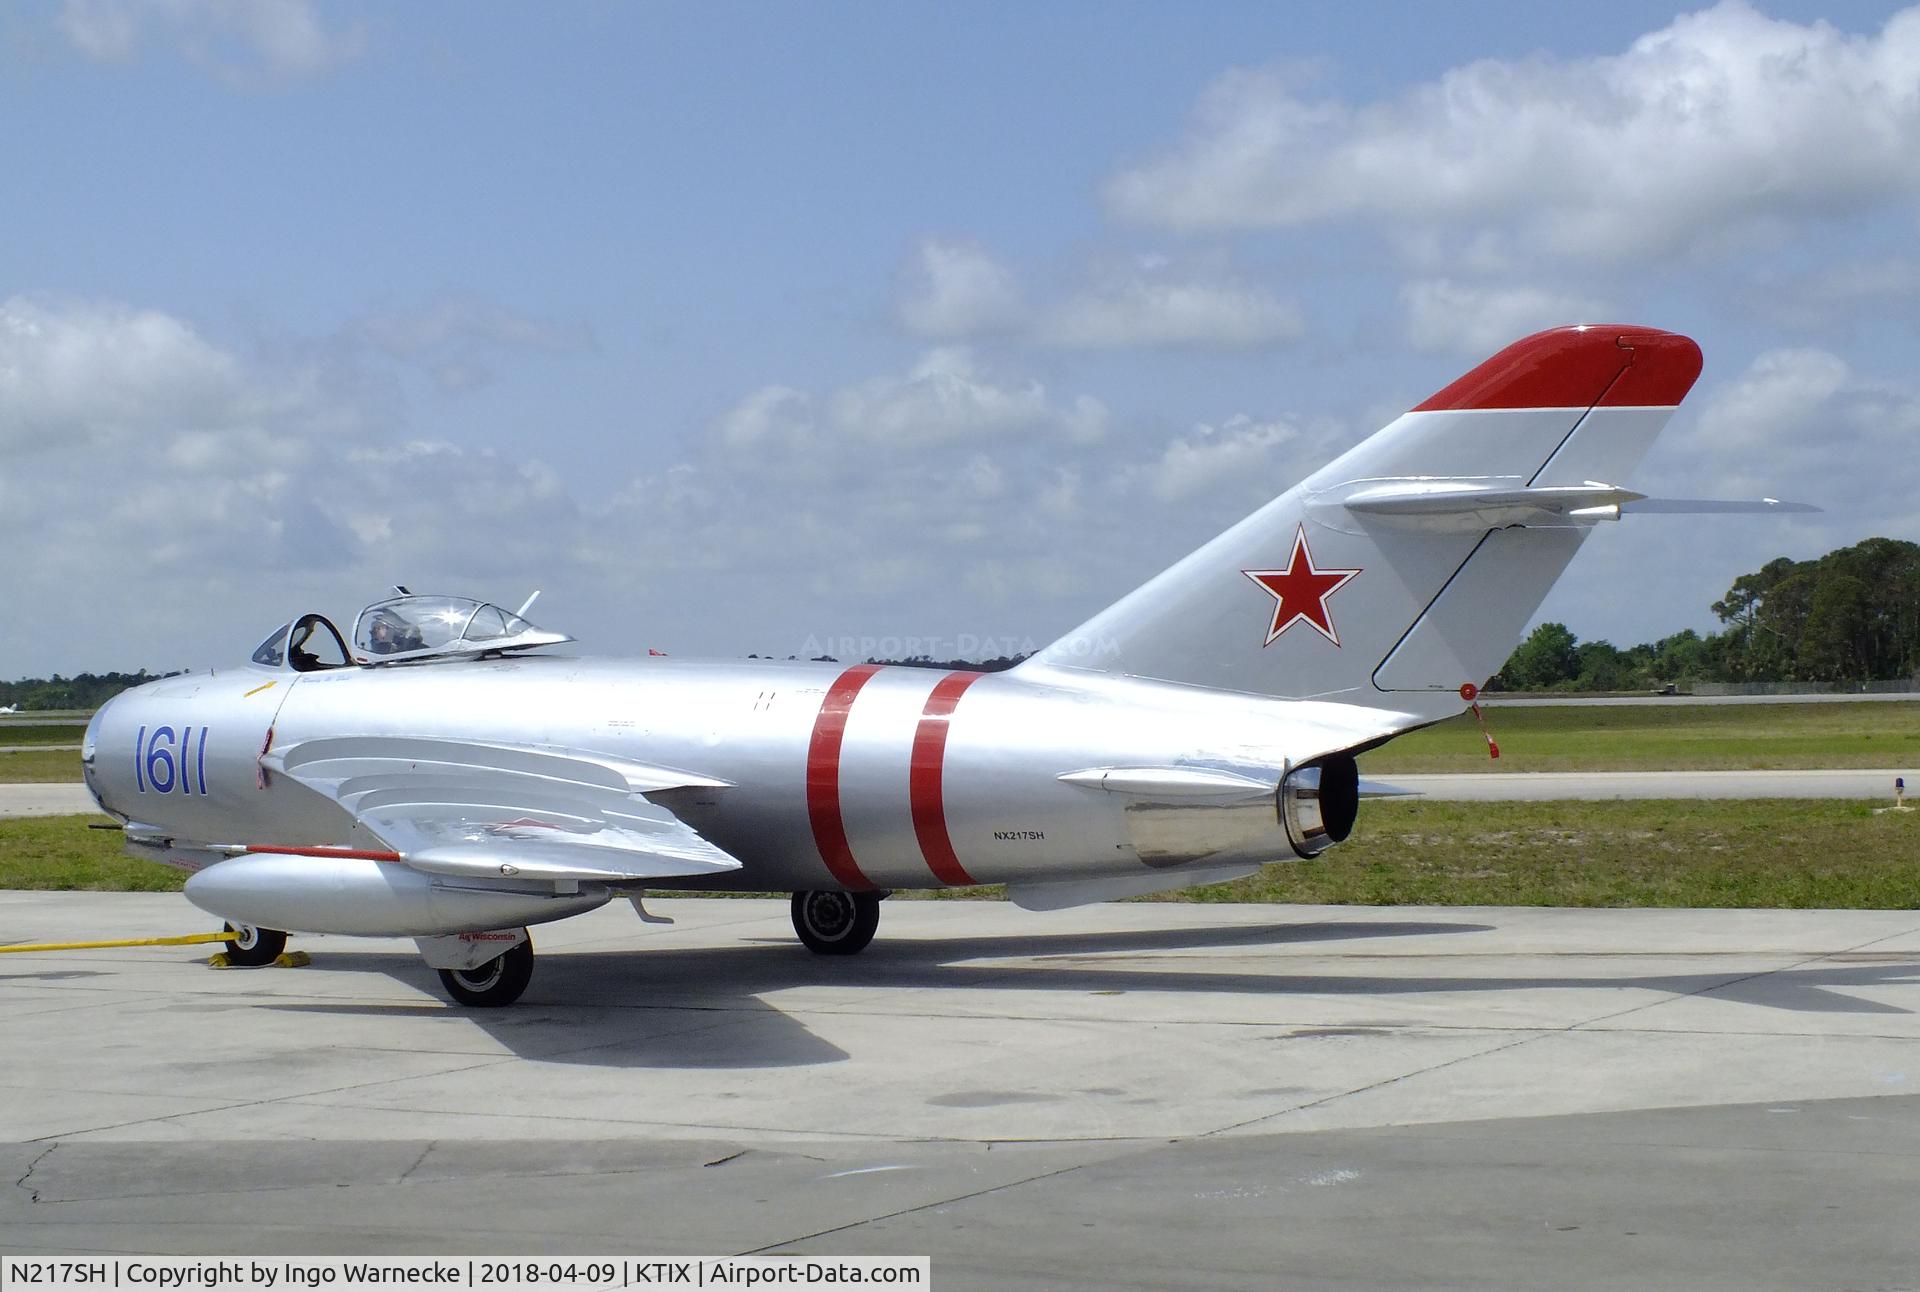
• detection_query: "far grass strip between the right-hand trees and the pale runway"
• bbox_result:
[1359,701,1920,778]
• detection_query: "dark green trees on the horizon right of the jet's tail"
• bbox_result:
[1488,538,1920,691]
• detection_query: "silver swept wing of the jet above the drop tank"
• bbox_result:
[259,735,739,883]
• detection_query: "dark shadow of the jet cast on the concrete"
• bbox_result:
[259,921,1920,1069]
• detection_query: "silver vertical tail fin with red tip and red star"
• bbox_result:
[1033,324,1701,712]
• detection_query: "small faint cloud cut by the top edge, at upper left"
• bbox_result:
[58,0,367,81]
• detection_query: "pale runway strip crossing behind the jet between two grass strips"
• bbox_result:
[0,768,1920,816]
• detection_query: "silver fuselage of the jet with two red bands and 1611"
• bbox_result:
[84,657,1409,891]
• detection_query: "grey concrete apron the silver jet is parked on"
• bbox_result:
[0,893,1920,1288]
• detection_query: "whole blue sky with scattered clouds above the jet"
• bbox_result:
[0,0,1920,676]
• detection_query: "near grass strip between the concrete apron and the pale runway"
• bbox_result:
[0,801,1920,910]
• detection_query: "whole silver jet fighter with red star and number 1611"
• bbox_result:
[83,326,1778,1006]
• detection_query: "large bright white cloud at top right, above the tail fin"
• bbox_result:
[1108,0,1920,259]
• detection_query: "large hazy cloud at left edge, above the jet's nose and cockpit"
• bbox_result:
[0,298,586,676]
